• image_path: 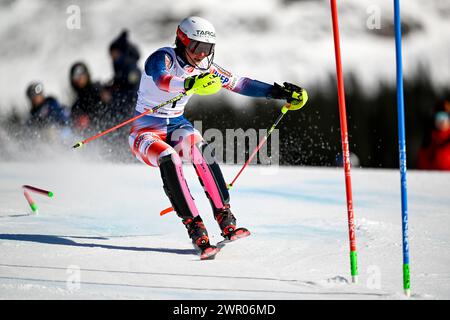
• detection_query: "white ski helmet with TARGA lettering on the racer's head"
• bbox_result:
[177,16,216,69]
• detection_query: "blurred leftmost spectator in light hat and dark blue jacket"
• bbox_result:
[26,82,69,128]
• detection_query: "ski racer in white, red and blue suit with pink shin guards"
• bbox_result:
[129,17,308,259]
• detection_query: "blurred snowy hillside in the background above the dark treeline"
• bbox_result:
[0,0,450,115]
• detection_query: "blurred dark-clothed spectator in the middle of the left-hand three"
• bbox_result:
[70,62,111,130]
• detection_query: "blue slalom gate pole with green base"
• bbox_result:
[394,0,411,297]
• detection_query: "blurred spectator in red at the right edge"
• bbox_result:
[417,111,450,170]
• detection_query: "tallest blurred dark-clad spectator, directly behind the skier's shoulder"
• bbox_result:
[109,30,141,120]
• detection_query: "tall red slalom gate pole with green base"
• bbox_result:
[330,0,358,283]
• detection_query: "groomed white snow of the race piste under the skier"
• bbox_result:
[0,159,450,300]
